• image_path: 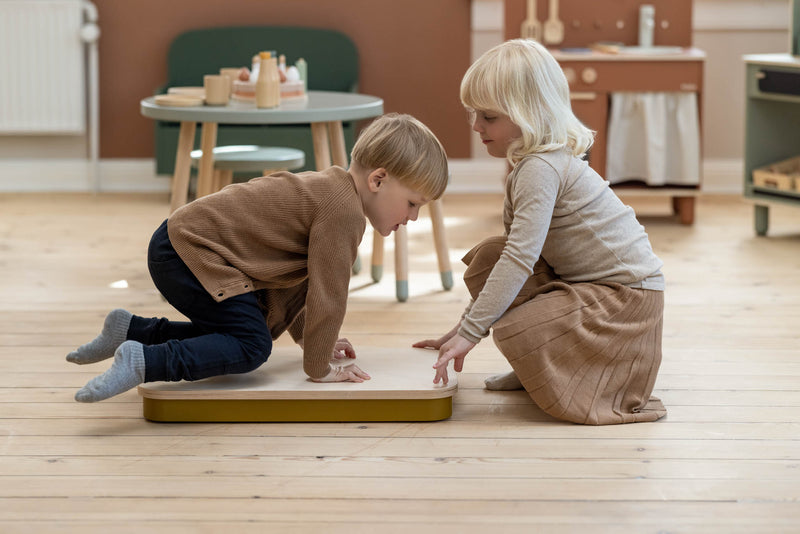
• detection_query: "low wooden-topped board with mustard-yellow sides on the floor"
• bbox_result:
[134,347,458,422]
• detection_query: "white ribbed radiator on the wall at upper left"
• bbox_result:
[0,0,87,135]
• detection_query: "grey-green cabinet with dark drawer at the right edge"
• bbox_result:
[744,54,800,236]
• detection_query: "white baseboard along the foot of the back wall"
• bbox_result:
[0,158,743,194]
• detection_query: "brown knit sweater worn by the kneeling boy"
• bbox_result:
[167,167,366,378]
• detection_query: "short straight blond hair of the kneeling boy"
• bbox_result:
[351,113,448,200]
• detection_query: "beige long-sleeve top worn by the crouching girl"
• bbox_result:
[459,150,664,343]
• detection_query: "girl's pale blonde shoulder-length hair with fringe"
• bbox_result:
[461,39,594,164]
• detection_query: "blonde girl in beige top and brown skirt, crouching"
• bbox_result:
[414,39,666,425]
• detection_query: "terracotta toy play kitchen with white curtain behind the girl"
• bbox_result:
[505,0,705,224]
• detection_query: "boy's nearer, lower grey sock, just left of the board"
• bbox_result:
[75,341,144,402]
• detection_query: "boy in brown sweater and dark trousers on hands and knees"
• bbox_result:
[67,114,447,402]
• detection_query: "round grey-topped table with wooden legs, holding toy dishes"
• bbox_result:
[140,91,383,211]
